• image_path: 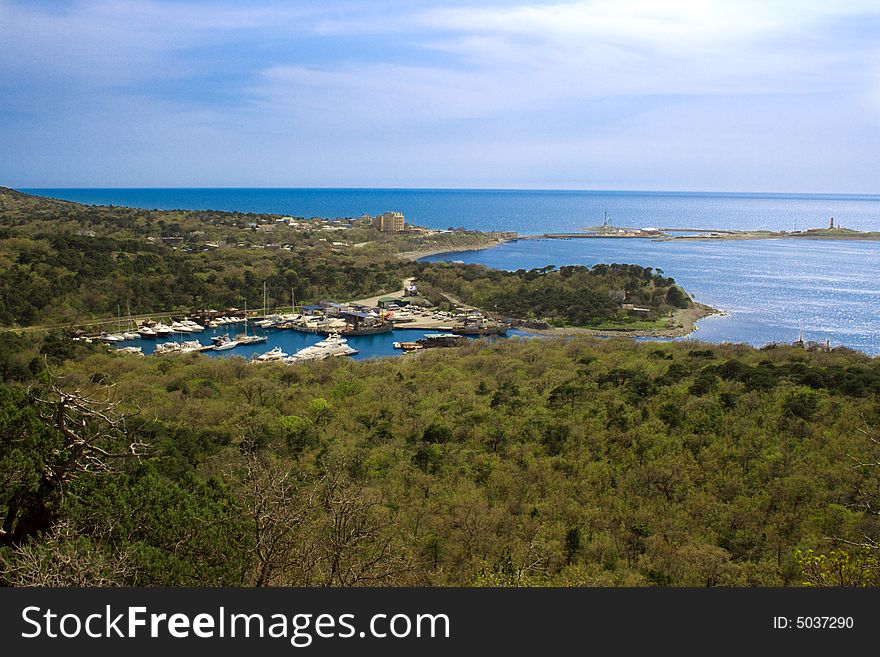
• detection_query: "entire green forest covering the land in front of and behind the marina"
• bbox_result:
[0,189,880,586]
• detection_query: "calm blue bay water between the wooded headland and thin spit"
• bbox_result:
[425,238,880,355]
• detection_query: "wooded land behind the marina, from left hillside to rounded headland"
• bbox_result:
[0,188,690,326]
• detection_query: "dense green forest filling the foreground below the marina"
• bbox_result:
[0,338,880,586]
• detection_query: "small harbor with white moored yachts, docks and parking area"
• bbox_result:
[87,279,526,364]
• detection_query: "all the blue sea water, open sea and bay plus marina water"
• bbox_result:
[22,188,880,357]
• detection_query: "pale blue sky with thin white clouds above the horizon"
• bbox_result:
[0,0,880,194]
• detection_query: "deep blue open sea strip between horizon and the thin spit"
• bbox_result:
[21,188,880,235]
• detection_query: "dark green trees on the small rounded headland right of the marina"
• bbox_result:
[419,264,691,326]
